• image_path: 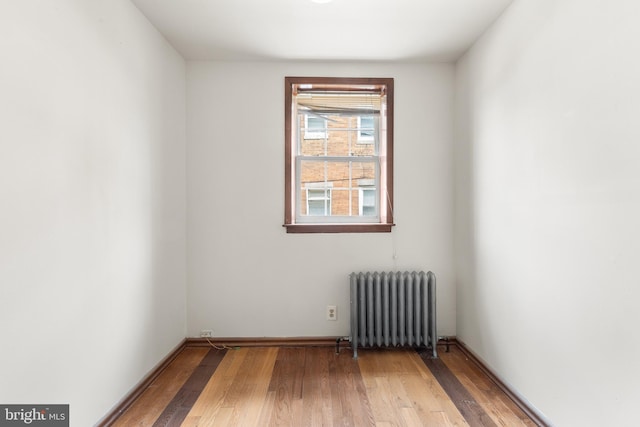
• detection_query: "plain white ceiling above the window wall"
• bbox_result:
[132,0,513,62]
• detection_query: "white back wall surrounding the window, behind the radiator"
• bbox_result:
[187,62,455,337]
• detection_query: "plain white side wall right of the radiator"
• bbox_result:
[455,0,640,426]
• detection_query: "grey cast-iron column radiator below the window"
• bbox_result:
[349,271,438,358]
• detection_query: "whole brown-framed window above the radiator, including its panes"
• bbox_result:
[284,77,393,233]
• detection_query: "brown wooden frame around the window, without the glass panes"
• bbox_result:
[284,77,395,233]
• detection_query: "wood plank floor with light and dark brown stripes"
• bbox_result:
[113,346,536,427]
